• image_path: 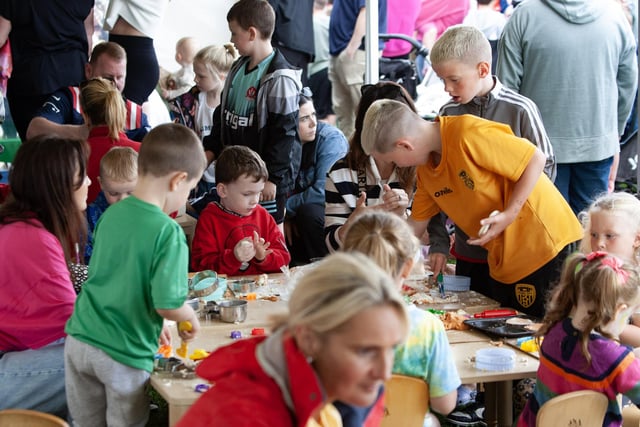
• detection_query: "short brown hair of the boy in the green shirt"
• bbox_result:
[138,123,207,180]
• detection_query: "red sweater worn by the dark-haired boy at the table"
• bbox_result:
[191,203,291,276]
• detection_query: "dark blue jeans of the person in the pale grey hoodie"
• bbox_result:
[555,157,613,215]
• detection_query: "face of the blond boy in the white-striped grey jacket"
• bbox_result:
[433,60,487,104]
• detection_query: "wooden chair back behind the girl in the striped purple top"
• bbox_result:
[536,390,609,427]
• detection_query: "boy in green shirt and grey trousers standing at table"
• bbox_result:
[65,123,205,426]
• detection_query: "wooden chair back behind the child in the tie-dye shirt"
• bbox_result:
[380,374,429,427]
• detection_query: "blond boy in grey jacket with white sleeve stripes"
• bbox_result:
[430,25,556,296]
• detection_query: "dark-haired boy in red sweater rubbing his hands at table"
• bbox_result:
[191,145,291,276]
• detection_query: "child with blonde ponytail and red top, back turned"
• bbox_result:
[80,77,140,203]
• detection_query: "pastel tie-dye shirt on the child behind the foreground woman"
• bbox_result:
[393,305,460,397]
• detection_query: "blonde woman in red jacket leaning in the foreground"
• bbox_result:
[178,253,408,427]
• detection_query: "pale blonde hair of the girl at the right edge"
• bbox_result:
[578,192,640,263]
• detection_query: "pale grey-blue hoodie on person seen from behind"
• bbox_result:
[496,0,638,163]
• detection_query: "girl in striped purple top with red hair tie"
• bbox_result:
[518,252,640,427]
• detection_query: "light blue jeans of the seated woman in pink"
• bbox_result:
[0,339,68,419]
